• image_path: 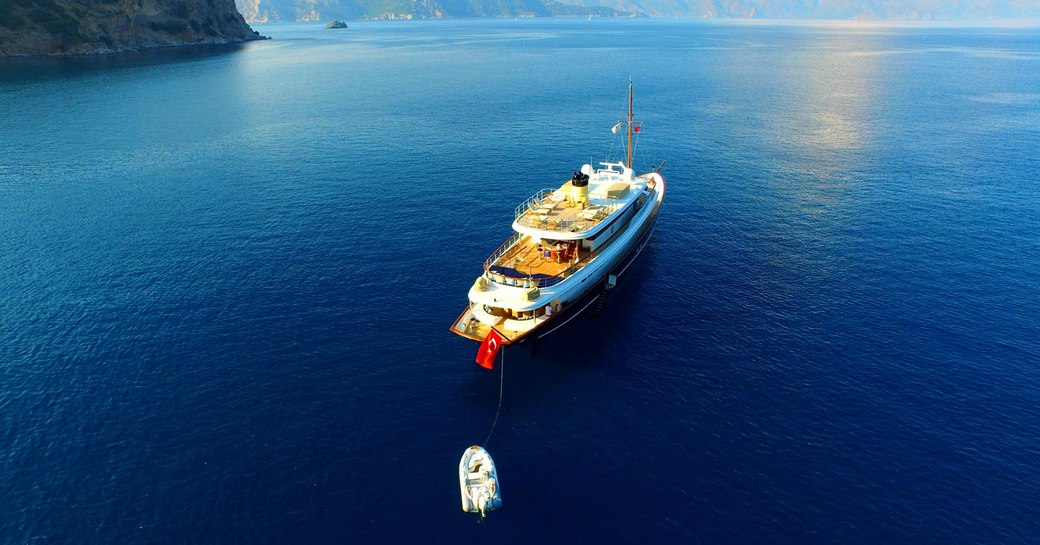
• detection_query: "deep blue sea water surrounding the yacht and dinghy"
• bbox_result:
[0,21,1040,544]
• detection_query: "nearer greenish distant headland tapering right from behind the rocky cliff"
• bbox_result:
[235,0,622,23]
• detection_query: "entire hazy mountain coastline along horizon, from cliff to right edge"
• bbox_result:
[235,0,1040,22]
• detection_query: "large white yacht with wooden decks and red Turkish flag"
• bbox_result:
[451,85,665,351]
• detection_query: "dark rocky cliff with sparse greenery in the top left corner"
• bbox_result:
[0,0,261,56]
